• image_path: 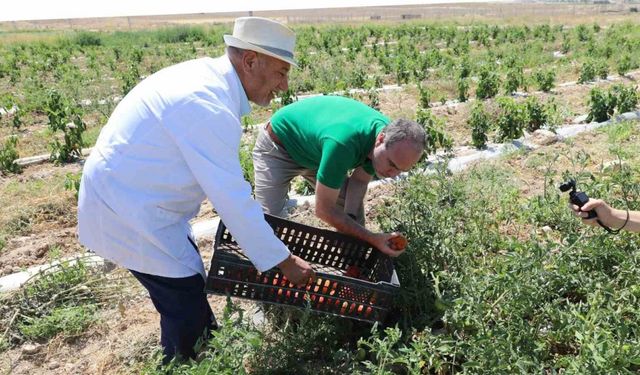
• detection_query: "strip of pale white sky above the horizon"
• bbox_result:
[0,0,500,21]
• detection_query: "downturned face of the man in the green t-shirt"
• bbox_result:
[371,133,422,178]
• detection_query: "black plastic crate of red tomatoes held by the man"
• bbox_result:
[205,215,400,322]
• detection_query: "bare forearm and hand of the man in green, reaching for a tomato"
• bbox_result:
[316,181,402,257]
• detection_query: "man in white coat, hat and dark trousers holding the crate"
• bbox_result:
[78,17,314,362]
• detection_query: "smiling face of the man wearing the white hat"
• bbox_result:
[245,54,291,106]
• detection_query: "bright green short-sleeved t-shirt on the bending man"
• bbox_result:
[271,96,390,189]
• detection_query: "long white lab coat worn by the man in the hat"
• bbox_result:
[78,55,289,277]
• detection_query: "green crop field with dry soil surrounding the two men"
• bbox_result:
[0,6,640,374]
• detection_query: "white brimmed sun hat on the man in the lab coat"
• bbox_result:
[224,17,298,66]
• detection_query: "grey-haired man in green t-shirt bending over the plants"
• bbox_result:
[253,96,426,256]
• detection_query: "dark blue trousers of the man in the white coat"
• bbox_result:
[129,270,218,364]
